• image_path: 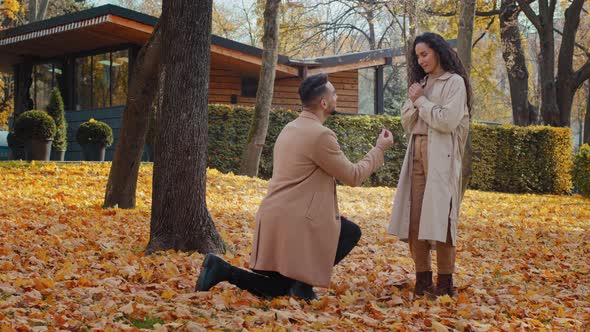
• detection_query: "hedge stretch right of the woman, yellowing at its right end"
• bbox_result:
[470,124,572,194]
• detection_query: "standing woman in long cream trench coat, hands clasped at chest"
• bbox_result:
[388,32,471,296]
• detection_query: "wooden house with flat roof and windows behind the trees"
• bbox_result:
[0,5,402,160]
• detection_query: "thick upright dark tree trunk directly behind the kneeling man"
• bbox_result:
[146,0,225,254]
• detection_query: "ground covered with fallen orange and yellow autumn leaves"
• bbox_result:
[0,163,590,332]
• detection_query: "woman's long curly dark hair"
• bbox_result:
[408,32,473,115]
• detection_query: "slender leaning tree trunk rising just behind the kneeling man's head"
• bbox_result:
[240,0,281,177]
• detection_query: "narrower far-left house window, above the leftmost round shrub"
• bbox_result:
[29,63,63,110]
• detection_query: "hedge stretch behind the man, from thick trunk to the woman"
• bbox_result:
[208,105,406,186]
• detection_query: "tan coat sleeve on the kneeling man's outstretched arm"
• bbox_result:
[312,130,383,187]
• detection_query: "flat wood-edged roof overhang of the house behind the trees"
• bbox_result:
[0,5,454,78]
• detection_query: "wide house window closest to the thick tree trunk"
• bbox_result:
[75,50,129,110]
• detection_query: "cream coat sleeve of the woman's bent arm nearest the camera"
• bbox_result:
[414,76,467,134]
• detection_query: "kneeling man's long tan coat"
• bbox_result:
[250,111,383,287]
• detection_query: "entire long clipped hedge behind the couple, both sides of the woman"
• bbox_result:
[208,105,572,194]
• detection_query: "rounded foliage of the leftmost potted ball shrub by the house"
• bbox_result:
[14,110,55,141]
